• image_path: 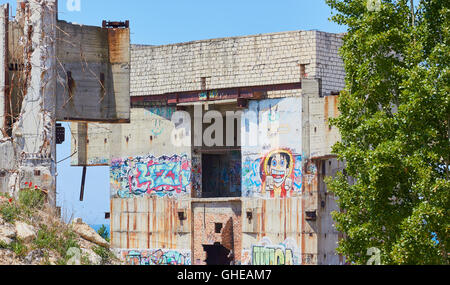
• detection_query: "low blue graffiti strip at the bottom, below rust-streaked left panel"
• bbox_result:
[122,249,191,265]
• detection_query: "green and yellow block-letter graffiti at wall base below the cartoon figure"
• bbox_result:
[242,235,299,265]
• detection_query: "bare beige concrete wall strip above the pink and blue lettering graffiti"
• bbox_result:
[71,105,182,166]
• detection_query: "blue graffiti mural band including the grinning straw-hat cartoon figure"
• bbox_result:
[242,149,302,198]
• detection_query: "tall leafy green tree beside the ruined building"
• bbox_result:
[326,0,450,264]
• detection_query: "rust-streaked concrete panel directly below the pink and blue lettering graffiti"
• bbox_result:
[111,197,191,250]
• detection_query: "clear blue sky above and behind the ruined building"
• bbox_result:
[0,0,346,224]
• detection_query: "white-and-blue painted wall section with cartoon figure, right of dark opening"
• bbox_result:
[241,97,302,198]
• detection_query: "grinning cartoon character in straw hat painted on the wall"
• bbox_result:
[263,150,295,198]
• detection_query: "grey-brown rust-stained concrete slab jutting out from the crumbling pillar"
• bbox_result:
[56,21,130,123]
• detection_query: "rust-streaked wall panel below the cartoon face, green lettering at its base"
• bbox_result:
[241,197,305,265]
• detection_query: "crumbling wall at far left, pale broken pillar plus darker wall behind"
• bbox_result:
[0,0,57,205]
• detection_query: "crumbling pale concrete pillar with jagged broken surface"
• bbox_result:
[13,0,57,206]
